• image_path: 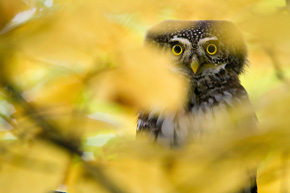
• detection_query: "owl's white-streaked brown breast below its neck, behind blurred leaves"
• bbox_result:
[138,74,248,145]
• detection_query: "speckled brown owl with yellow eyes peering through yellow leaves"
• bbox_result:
[137,20,257,193]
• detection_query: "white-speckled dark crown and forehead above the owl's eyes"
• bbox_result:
[146,20,237,43]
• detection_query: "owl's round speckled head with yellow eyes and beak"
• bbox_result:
[145,20,247,77]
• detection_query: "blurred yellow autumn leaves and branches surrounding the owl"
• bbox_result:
[0,0,290,193]
